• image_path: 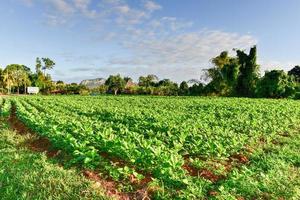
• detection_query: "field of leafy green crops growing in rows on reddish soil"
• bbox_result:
[1,96,300,199]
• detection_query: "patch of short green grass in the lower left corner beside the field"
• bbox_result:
[0,121,108,200]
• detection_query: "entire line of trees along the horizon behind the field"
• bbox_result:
[0,46,300,99]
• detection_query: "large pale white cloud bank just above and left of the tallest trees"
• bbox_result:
[120,30,256,65]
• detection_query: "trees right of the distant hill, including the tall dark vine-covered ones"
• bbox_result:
[96,46,300,99]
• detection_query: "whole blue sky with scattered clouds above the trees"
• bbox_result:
[0,0,300,82]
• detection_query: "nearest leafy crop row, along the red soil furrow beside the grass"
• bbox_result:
[16,100,190,191]
